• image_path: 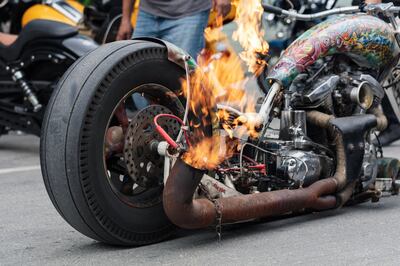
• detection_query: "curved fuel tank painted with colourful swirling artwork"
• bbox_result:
[267,14,399,87]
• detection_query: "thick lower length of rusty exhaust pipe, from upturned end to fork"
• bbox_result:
[163,159,337,229]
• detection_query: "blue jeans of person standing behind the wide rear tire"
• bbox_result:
[133,10,210,59]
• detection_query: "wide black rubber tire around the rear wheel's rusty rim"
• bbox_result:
[41,41,191,246]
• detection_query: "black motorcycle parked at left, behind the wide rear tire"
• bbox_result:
[0,20,97,136]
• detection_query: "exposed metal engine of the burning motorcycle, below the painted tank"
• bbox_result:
[217,62,383,193]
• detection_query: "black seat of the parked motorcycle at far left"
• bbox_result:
[0,20,78,62]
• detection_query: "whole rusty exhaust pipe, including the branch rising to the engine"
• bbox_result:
[163,111,379,229]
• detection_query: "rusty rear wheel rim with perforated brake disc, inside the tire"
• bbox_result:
[103,84,183,208]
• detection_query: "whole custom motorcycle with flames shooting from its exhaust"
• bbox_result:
[41,0,400,245]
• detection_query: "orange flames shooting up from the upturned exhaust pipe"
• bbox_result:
[182,0,268,169]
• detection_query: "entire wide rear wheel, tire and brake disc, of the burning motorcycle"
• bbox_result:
[41,41,197,245]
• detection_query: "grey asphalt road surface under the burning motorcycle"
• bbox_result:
[0,136,400,265]
